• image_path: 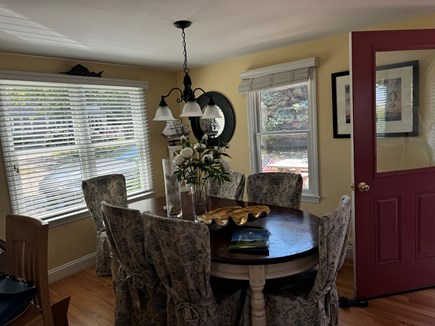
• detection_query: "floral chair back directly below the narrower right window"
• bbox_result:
[246,172,303,209]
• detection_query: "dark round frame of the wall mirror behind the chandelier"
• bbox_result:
[190,92,236,146]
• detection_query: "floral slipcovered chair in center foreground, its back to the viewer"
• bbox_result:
[143,212,250,326]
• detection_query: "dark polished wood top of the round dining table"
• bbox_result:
[132,193,320,265]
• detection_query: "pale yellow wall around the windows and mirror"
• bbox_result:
[0,15,435,269]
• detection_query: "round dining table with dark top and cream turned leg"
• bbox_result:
[130,193,320,326]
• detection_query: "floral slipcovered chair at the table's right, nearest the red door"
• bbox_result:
[258,195,352,326]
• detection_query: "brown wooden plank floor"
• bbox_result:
[50,261,435,326]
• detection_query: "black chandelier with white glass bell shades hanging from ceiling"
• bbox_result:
[153,20,221,121]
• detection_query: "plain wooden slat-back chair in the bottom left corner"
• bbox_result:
[6,214,54,326]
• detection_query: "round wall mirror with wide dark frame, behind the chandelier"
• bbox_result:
[190,92,236,146]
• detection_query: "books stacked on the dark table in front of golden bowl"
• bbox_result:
[229,228,270,255]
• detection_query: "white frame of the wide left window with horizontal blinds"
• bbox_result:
[0,70,154,225]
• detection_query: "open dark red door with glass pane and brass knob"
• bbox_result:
[351,30,435,299]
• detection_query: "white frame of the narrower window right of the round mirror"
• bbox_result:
[244,58,320,203]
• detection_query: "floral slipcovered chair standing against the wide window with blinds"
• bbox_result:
[82,174,128,278]
